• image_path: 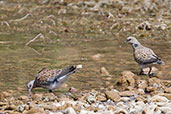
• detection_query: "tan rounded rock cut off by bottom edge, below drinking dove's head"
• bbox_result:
[27,107,46,114]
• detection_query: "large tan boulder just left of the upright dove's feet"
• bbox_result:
[117,71,135,87]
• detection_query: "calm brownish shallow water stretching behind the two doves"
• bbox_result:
[0,32,171,94]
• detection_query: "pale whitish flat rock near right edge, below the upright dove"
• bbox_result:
[150,95,169,103]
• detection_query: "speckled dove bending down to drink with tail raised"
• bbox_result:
[27,65,82,98]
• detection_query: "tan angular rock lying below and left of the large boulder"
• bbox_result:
[105,91,120,102]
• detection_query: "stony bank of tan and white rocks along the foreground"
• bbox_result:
[0,71,171,114]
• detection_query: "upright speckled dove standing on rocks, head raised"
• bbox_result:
[125,37,165,77]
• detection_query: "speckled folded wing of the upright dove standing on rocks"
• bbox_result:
[134,47,158,64]
